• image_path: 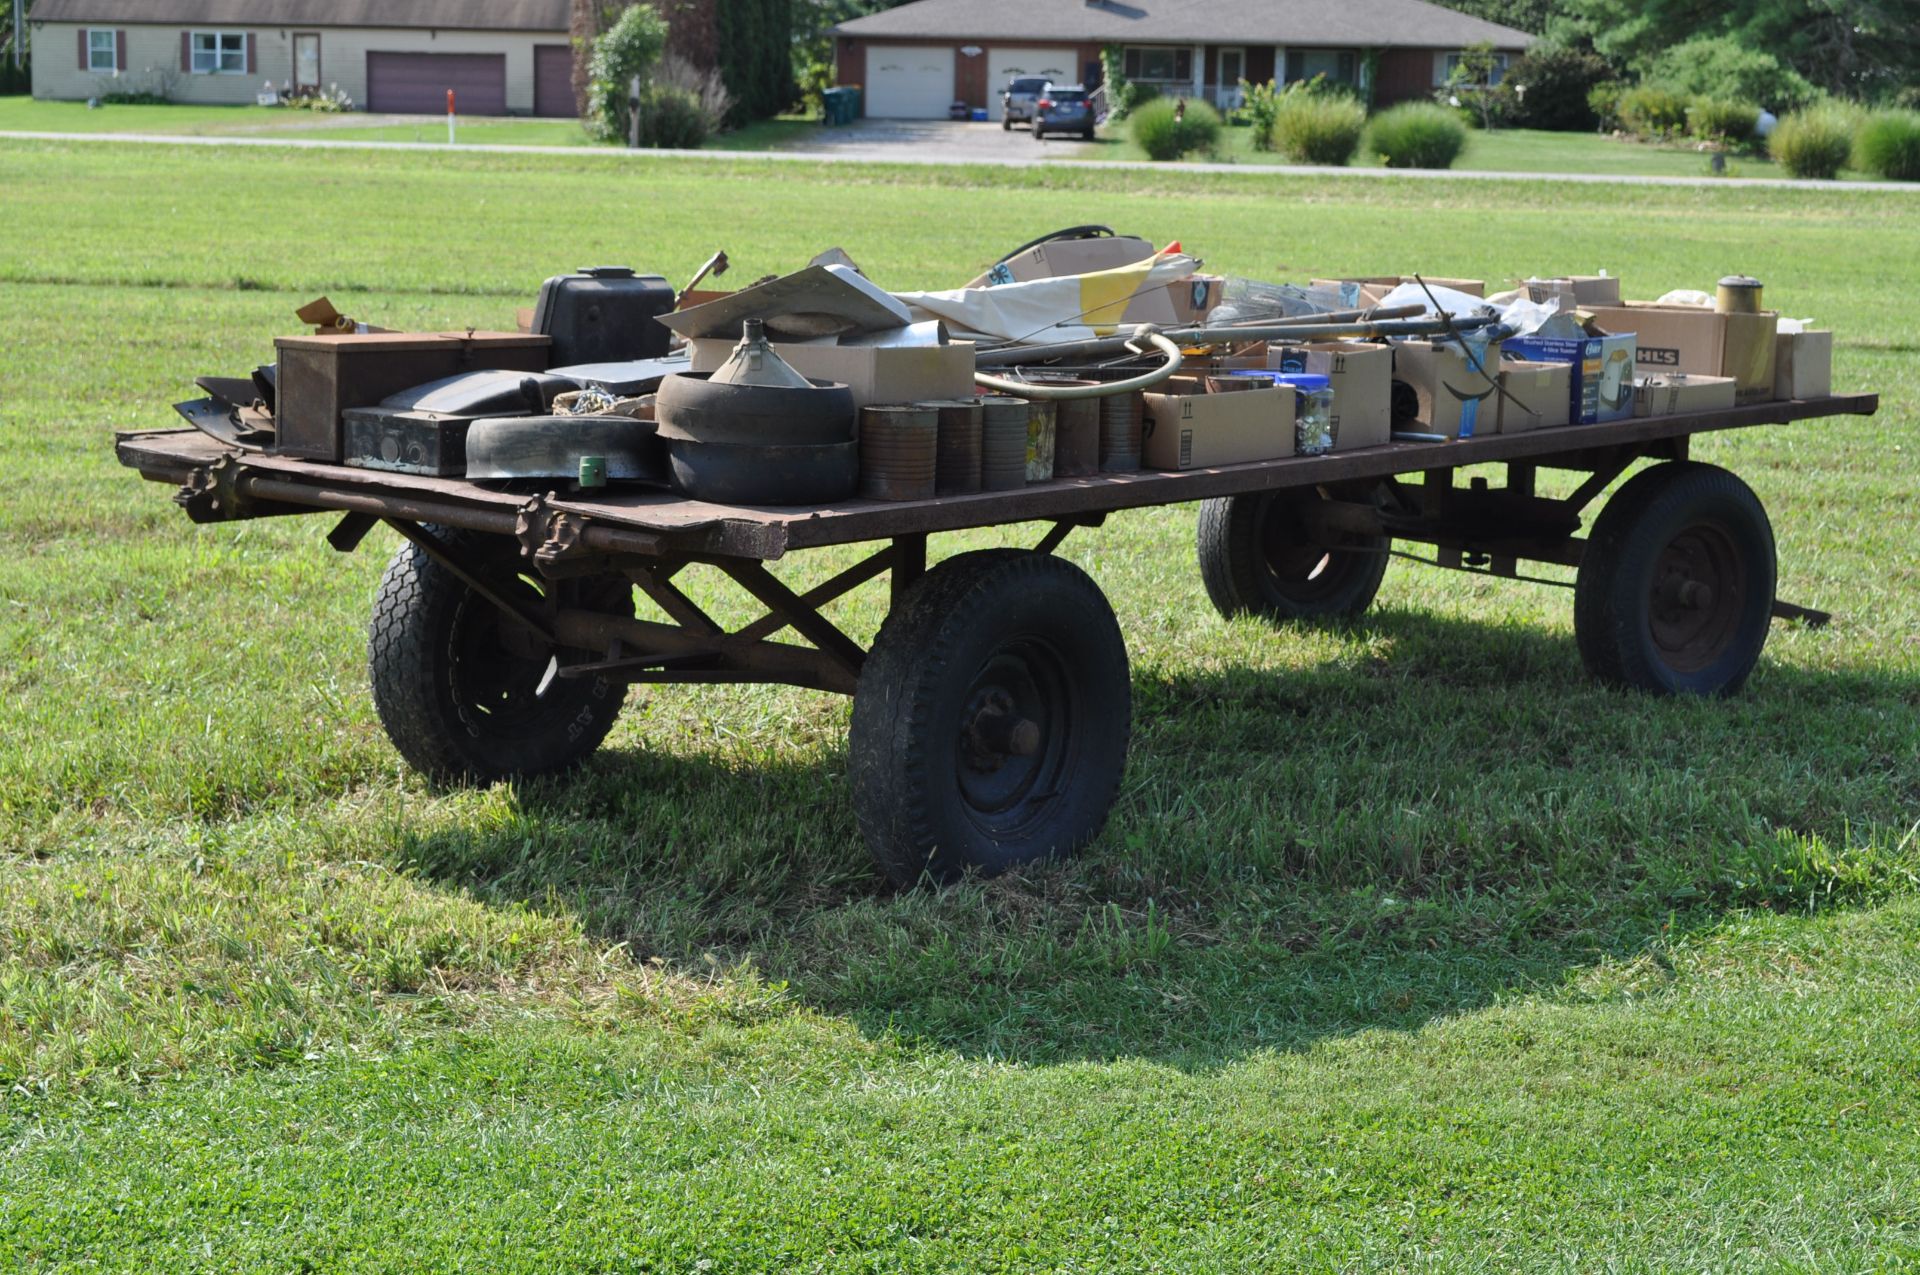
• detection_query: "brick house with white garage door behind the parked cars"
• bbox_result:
[833,0,1532,119]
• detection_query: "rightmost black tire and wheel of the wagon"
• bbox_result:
[1572,461,1778,695]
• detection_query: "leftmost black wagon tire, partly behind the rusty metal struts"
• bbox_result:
[367,528,634,783]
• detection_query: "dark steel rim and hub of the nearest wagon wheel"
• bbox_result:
[954,638,1077,839]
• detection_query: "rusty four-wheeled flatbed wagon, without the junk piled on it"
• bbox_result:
[117,394,1878,883]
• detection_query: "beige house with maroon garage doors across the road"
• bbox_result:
[31,0,576,117]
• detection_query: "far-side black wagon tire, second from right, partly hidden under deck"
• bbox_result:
[1194,488,1392,622]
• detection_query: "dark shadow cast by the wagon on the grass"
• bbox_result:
[401,613,1920,1068]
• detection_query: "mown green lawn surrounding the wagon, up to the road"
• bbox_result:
[0,142,1920,1271]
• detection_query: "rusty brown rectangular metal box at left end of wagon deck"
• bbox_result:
[273,332,551,463]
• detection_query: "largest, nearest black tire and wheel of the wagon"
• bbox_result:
[849,549,1133,887]
